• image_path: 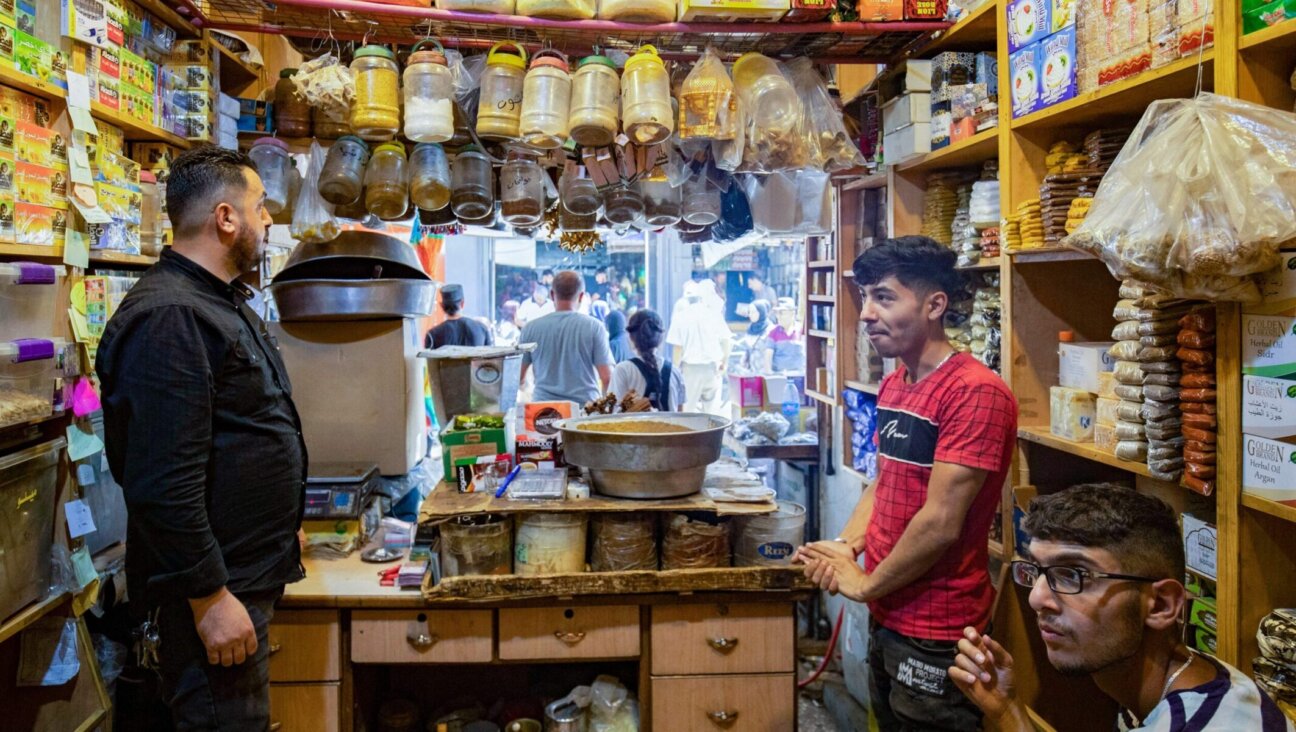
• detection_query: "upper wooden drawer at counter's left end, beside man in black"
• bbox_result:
[270,610,342,681]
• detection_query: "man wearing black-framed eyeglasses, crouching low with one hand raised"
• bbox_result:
[949,485,1293,732]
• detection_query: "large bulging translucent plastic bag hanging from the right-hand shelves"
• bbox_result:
[1063,93,1296,301]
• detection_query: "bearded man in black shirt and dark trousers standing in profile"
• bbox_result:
[96,146,306,729]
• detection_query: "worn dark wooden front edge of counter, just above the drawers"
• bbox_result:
[422,566,815,604]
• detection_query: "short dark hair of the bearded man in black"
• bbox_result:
[166,145,257,233]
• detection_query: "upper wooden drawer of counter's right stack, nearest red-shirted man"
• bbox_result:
[651,602,796,676]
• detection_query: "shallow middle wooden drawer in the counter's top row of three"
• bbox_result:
[499,605,639,661]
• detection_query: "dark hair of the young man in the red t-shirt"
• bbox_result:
[851,236,963,302]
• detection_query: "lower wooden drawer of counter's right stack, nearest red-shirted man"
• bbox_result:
[652,674,796,732]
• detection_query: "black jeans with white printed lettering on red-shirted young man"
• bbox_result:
[868,623,981,732]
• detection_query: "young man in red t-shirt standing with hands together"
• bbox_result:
[797,236,1017,731]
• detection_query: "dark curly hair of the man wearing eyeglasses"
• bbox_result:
[1023,483,1183,580]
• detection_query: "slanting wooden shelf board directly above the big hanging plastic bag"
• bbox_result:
[1011,48,1214,131]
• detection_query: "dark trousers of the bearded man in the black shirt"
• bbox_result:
[158,589,284,732]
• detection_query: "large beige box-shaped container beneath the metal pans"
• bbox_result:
[268,319,428,475]
